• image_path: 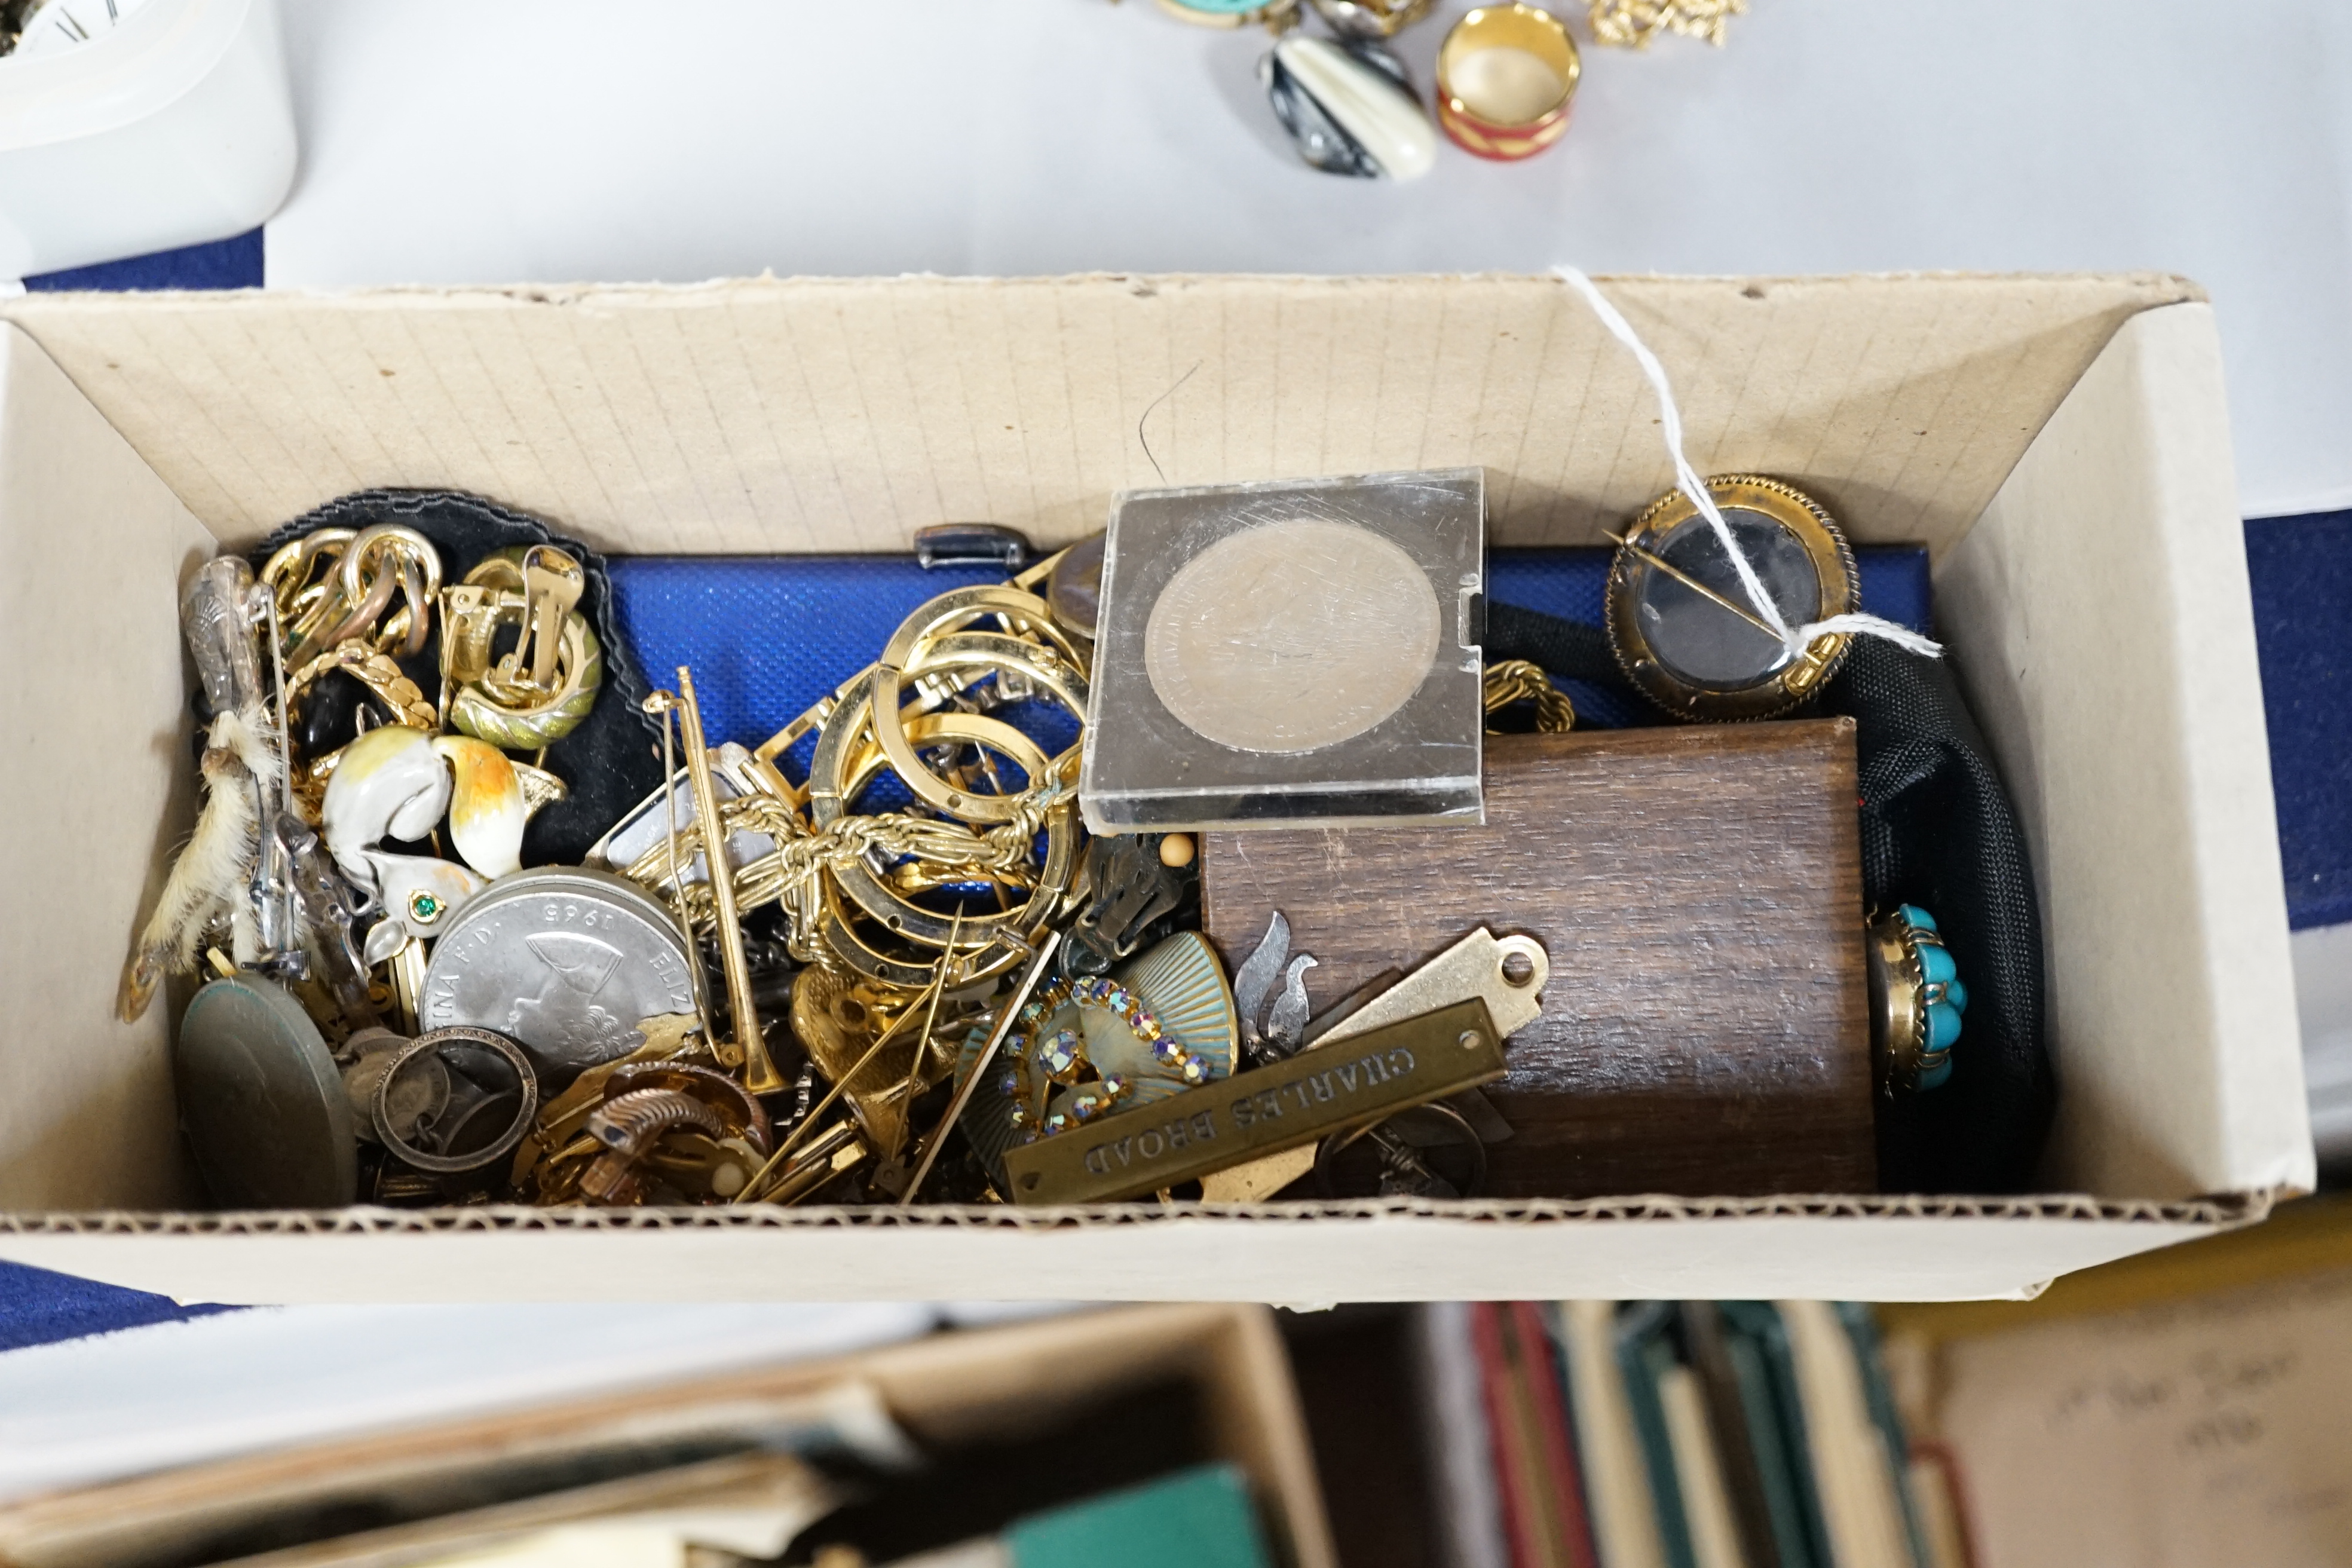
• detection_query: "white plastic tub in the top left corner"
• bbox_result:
[0,0,294,277]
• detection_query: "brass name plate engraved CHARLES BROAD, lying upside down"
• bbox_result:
[1004,997,1503,1203]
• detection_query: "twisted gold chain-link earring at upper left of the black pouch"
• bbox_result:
[261,522,442,667]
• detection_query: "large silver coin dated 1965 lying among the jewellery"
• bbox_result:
[419,868,694,1074]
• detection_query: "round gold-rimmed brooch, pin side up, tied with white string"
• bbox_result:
[1604,475,1860,722]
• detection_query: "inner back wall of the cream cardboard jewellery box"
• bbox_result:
[0,272,2201,555]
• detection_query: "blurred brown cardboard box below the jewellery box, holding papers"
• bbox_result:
[0,1304,1336,1568]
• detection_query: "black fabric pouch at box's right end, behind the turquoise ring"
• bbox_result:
[1487,604,2058,1194]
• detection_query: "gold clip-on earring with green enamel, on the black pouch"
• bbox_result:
[440,546,605,752]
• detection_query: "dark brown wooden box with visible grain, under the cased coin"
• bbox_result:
[1202,719,1877,1196]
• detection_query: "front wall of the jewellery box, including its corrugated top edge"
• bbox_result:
[0,1194,2272,1302]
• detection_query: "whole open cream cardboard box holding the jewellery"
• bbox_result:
[0,275,2312,1302]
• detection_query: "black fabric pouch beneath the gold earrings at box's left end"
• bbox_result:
[249,489,661,865]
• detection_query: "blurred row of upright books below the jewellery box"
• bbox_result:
[1423,1302,1968,1568]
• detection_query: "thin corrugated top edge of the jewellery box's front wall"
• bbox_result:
[0,1192,2291,1236]
